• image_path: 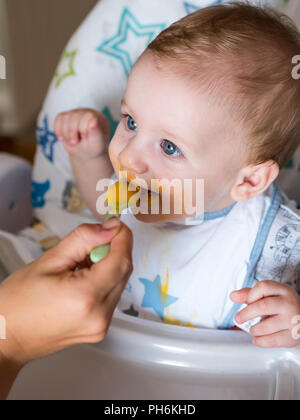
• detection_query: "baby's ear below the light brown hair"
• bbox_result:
[231,160,279,201]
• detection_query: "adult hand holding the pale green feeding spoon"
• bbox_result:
[0,219,132,390]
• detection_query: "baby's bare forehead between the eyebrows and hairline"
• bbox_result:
[124,57,241,153]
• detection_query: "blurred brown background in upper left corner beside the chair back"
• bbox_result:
[0,0,96,136]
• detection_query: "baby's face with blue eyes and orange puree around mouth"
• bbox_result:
[109,53,245,222]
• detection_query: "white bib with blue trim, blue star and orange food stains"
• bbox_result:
[118,184,300,331]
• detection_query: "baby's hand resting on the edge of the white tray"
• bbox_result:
[231,281,300,348]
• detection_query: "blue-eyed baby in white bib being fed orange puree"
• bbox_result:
[55,3,300,347]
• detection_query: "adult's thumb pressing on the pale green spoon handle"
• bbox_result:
[48,219,121,270]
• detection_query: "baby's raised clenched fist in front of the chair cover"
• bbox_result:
[54,109,110,161]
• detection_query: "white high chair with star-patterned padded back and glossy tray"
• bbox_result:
[0,0,300,400]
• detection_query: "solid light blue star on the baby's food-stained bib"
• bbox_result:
[139,276,178,320]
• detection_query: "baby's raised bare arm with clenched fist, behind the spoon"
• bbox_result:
[55,109,113,221]
